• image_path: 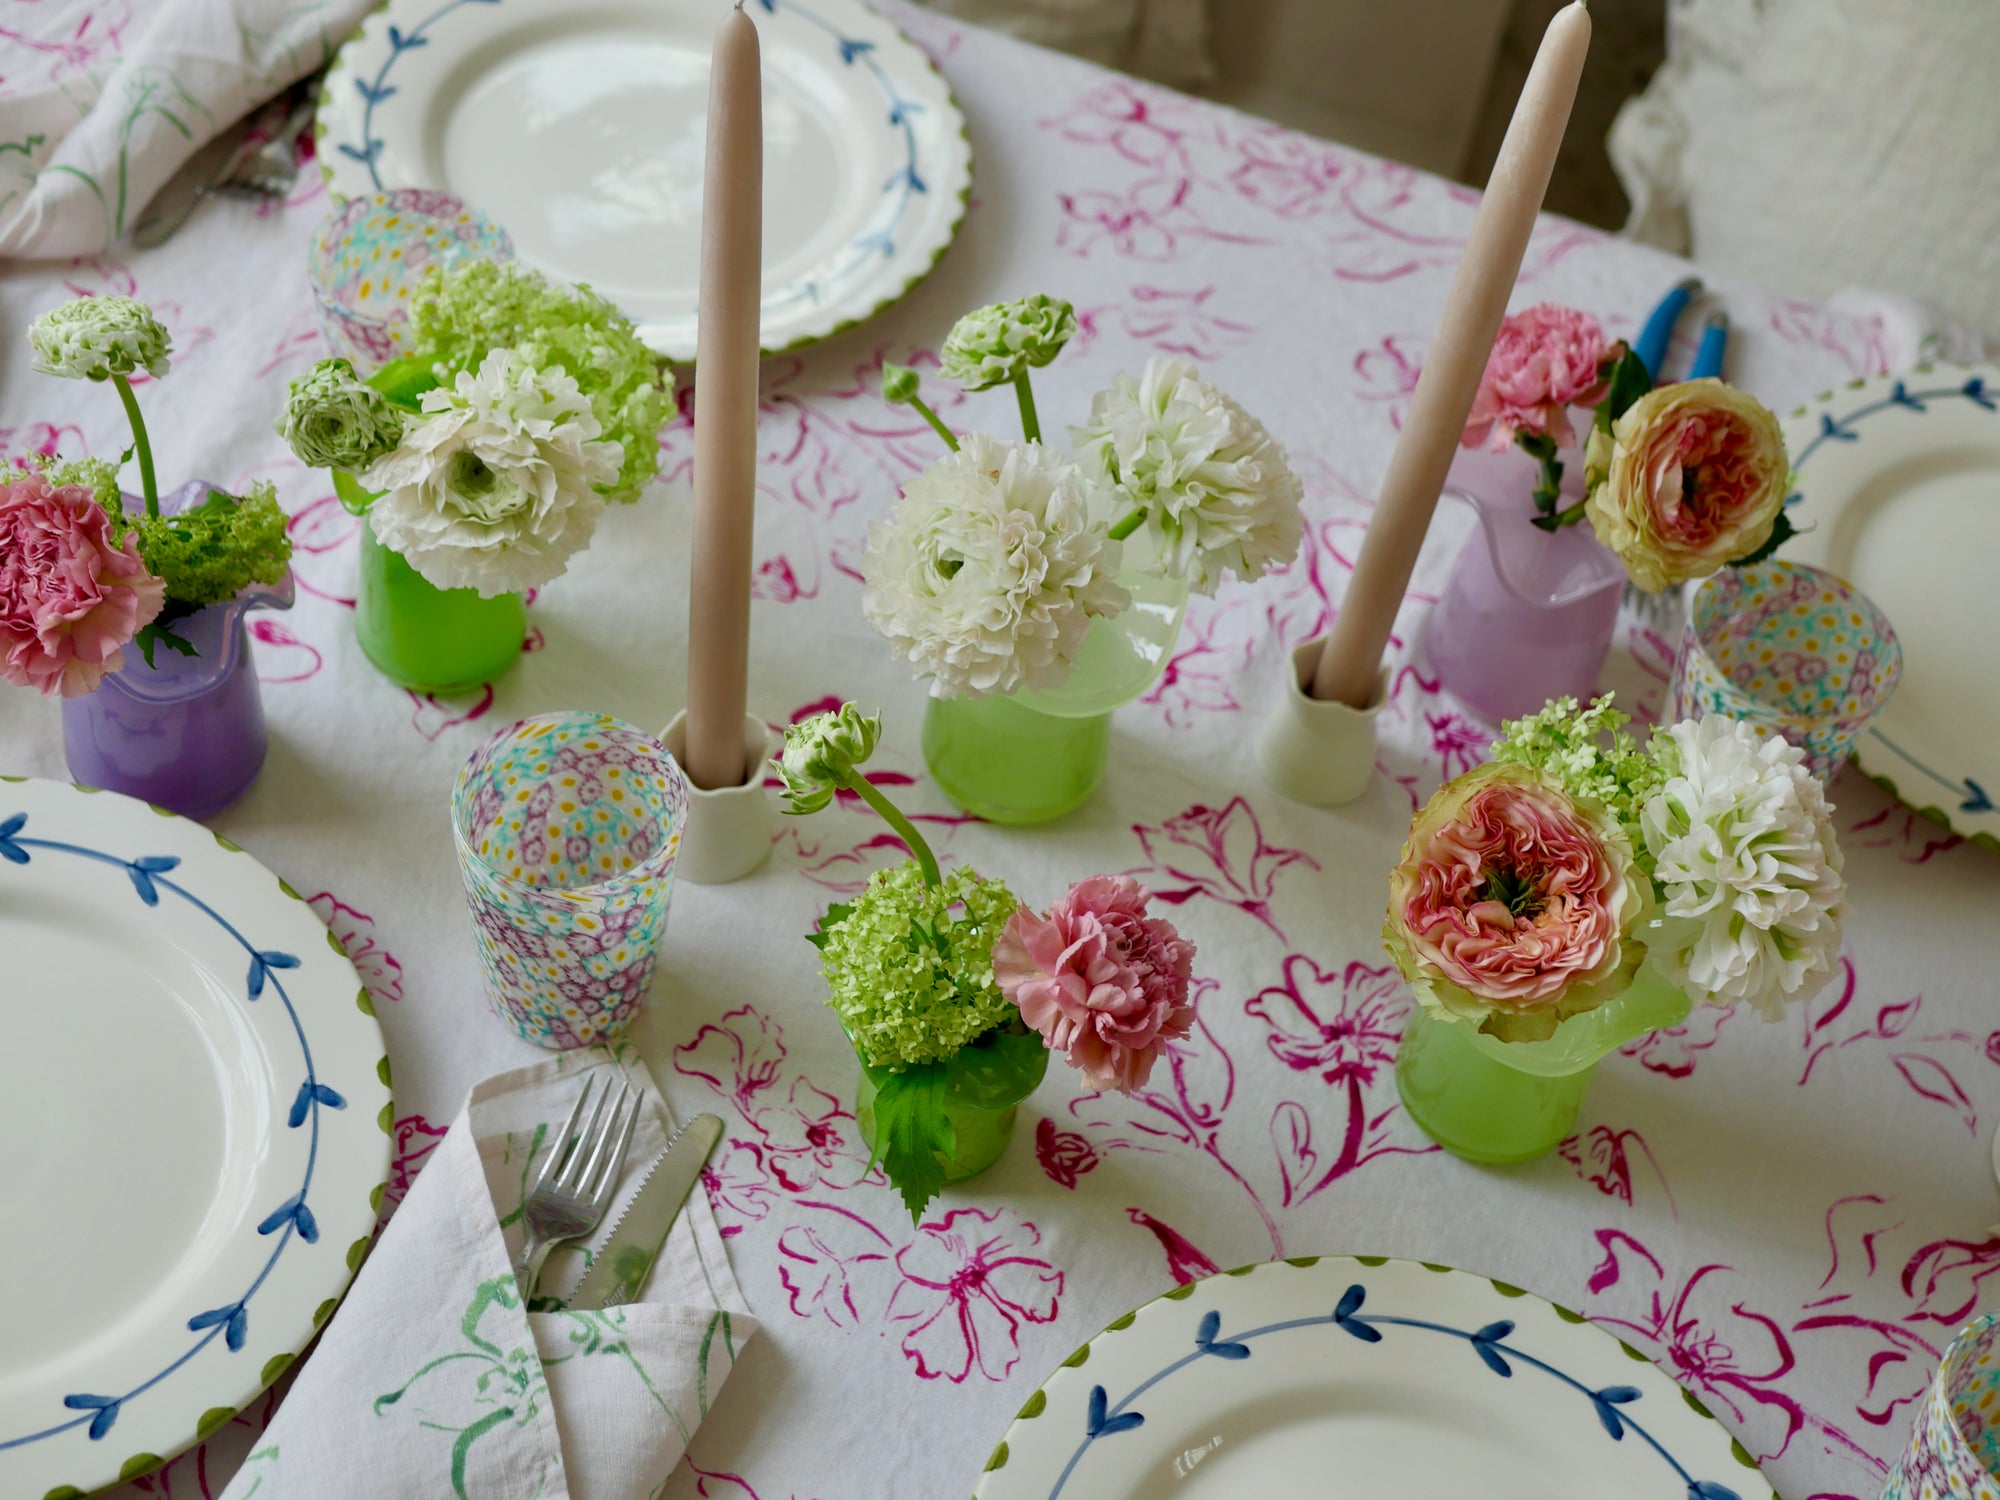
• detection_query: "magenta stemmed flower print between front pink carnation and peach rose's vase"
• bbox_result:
[1244,954,1432,1206]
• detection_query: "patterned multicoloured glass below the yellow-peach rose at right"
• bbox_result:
[1672,562,1902,780]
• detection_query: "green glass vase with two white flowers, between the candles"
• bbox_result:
[924,572,1188,824]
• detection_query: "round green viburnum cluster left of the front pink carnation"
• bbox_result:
[814,862,1020,1072]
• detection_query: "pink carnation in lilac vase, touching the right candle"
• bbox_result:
[1460,302,1612,452]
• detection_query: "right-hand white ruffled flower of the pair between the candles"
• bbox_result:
[1070,358,1306,594]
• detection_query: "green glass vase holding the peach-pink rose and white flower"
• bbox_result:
[1396,964,1694,1164]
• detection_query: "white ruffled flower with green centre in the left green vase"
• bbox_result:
[360,348,624,598]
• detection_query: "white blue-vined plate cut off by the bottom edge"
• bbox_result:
[978,1256,1776,1500]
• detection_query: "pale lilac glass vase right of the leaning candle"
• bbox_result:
[1426,438,1626,724]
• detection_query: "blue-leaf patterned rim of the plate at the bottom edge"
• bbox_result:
[976,1256,1776,1500]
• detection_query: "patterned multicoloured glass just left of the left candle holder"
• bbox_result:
[452,712,688,1048]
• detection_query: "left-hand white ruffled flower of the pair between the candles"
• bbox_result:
[862,432,1132,698]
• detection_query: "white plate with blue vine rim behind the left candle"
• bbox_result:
[318,0,972,360]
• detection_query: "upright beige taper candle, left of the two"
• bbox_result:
[684,0,764,792]
